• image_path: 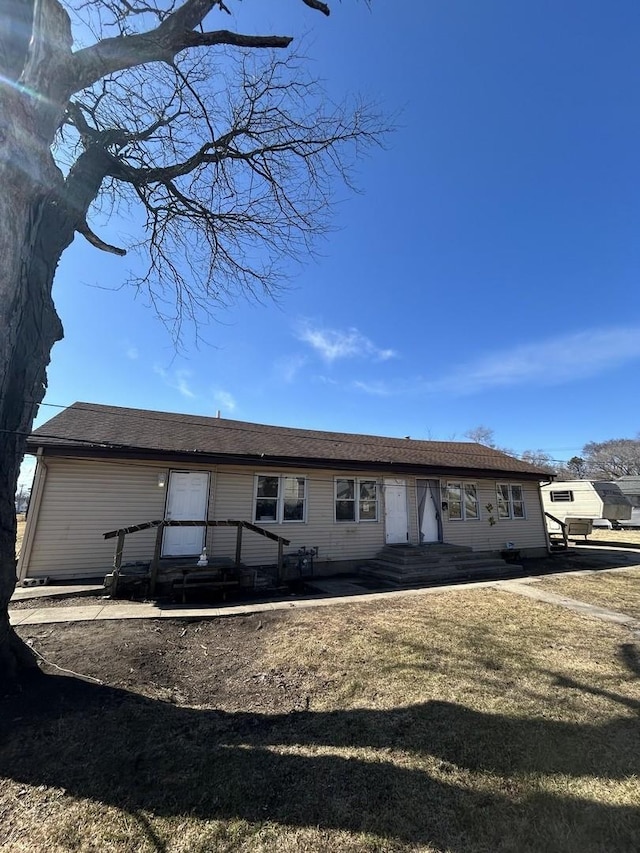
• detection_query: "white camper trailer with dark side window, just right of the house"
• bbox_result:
[540,480,632,533]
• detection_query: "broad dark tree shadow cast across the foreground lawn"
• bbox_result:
[0,664,640,853]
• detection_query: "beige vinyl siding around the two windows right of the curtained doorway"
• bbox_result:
[442,477,547,551]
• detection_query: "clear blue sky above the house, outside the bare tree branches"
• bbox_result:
[20,0,640,486]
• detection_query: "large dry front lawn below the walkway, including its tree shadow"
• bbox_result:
[0,589,640,853]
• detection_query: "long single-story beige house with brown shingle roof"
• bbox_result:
[18,402,548,580]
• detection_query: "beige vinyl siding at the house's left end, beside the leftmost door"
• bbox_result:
[19,457,215,578]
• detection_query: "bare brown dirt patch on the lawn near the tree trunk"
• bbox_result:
[17,602,314,711]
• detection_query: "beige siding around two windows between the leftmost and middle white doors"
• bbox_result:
[208,467,384,565]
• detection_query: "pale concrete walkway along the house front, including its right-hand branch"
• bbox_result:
[9,564,640,633]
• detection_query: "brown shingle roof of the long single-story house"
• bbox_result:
[28,403,548,479]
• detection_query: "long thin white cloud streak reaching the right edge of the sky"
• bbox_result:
[424,326,640,394]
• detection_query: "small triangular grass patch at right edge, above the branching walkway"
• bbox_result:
[536,568,640,620]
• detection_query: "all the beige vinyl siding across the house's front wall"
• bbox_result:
[19,457,546,578]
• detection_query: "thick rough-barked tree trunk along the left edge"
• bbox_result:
[0,0,73,685]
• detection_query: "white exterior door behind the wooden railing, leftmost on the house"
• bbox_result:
[162,471,209,557]
